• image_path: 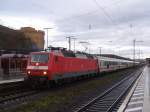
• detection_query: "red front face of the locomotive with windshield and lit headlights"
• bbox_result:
[27,52,50,81]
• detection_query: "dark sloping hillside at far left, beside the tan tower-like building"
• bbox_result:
[0,25,32,50]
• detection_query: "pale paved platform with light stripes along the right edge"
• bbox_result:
[118,66,150,112]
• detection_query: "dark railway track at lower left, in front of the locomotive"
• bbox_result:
[0,82,39,111]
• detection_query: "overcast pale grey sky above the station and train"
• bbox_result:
[0,0,150,58]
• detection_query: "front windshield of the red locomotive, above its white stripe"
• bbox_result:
[31,54,49,63]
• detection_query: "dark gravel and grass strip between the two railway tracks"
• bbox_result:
[3,69,142,112]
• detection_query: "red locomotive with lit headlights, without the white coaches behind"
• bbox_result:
[27,47,98,84]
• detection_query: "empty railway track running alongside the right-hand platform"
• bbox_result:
[74,68,143,112]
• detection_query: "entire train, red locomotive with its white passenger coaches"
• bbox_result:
[26,47,138,85]
